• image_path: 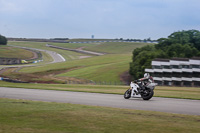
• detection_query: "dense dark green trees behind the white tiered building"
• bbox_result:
[129,30,200,79]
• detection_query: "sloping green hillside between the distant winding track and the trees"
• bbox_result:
[1,42,152,84]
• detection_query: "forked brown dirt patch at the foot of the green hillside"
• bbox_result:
[1,67,89,84]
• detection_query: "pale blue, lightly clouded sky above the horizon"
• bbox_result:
[0,0,200,39]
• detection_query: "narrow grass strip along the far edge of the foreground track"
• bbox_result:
[0,81,200,100]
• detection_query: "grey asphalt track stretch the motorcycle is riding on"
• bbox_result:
[0,87,200,115]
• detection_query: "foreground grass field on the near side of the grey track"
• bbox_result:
[0,98,200,133]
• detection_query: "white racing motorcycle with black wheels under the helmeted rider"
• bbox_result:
[124,81,157,100]
